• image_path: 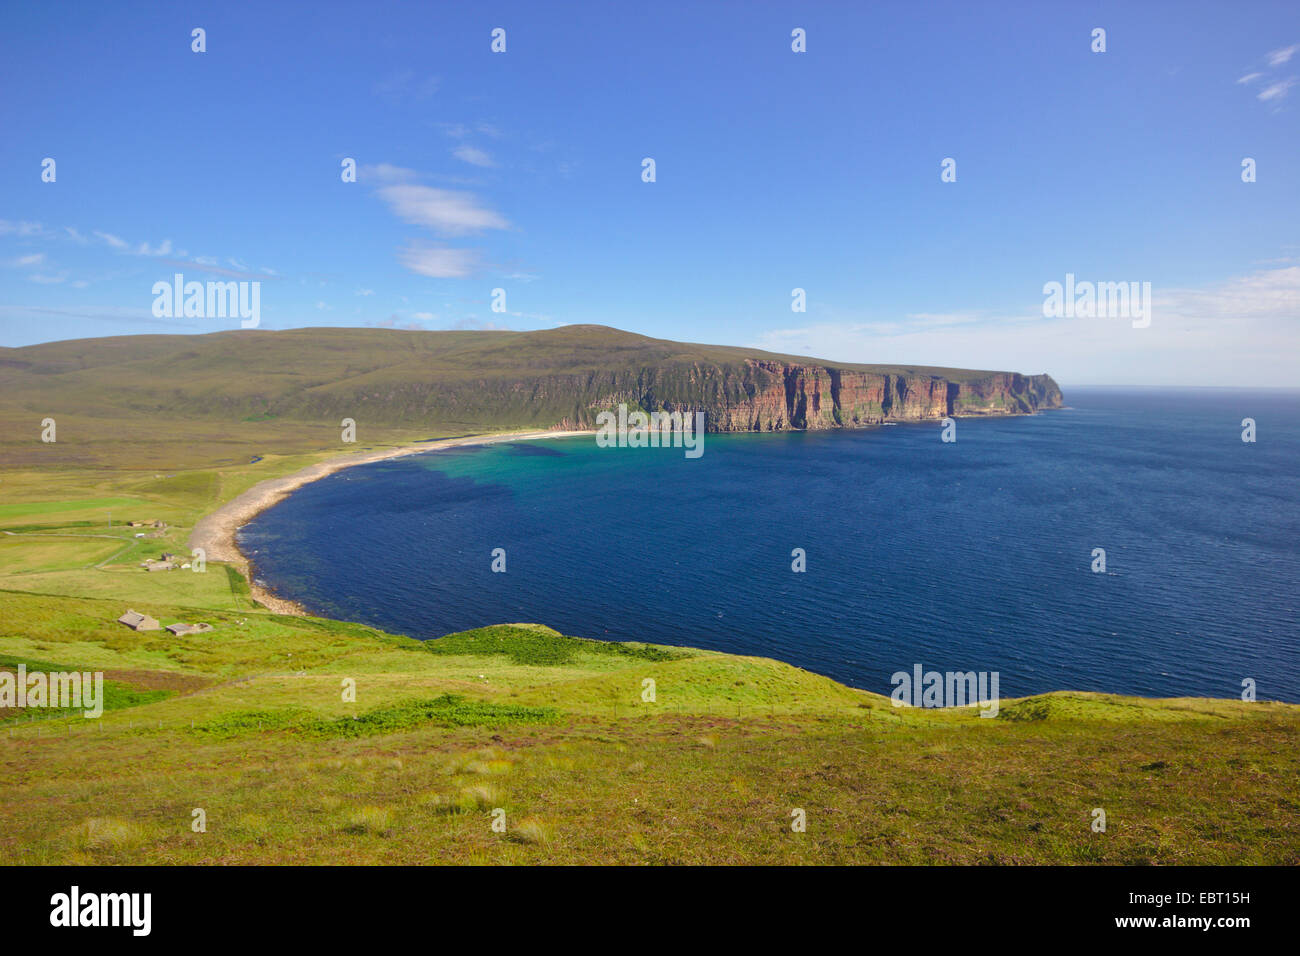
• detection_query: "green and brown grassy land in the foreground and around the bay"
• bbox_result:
[0,340,1300,864]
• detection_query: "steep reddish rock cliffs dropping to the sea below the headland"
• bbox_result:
[563,360,1062,432]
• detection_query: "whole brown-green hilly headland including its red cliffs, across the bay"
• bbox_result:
[0,325,1061,434]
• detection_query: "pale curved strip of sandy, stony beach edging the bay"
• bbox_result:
[190,431,595,615]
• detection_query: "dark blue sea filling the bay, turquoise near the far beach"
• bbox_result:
[241,388,1300,702]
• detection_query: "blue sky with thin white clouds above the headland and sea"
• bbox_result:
[0,1,1300,386]
